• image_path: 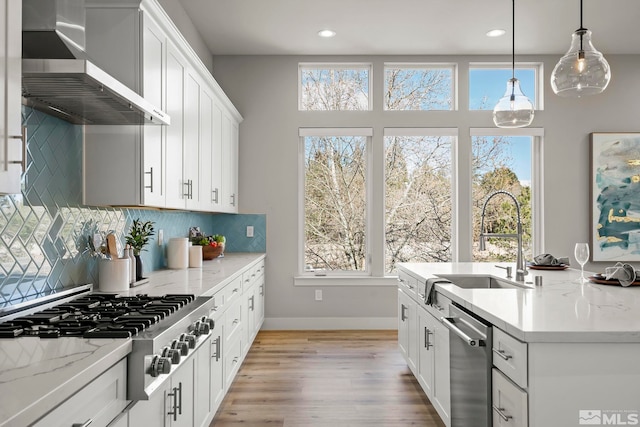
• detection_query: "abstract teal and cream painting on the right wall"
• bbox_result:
[591,133,640,262]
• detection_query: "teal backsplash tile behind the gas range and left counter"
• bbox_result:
[0,107,266,307]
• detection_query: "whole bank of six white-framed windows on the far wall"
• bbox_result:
[296,61,544,280]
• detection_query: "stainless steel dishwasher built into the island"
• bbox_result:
[440,303,492,427]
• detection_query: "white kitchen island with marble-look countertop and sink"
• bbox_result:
[399,263,640,427]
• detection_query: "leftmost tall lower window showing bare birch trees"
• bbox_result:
[300,129,371,274]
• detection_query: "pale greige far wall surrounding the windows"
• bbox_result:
[213,55,640,328]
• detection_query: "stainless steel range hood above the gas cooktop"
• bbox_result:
[22,0,170,125]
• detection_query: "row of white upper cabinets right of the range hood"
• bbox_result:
[84,0,242,212]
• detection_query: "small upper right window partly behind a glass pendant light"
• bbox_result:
[469,64,542,110]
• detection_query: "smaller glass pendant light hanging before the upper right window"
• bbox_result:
[493,0,534,128]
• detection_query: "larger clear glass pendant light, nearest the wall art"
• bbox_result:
[551,0,611,97]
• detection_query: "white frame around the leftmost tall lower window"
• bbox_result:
[298,127,373,278]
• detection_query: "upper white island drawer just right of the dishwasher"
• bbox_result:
[493,328,527,388]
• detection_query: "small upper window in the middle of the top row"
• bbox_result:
[384,64,455,110]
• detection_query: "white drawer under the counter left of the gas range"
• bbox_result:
[34,359,127,427]
